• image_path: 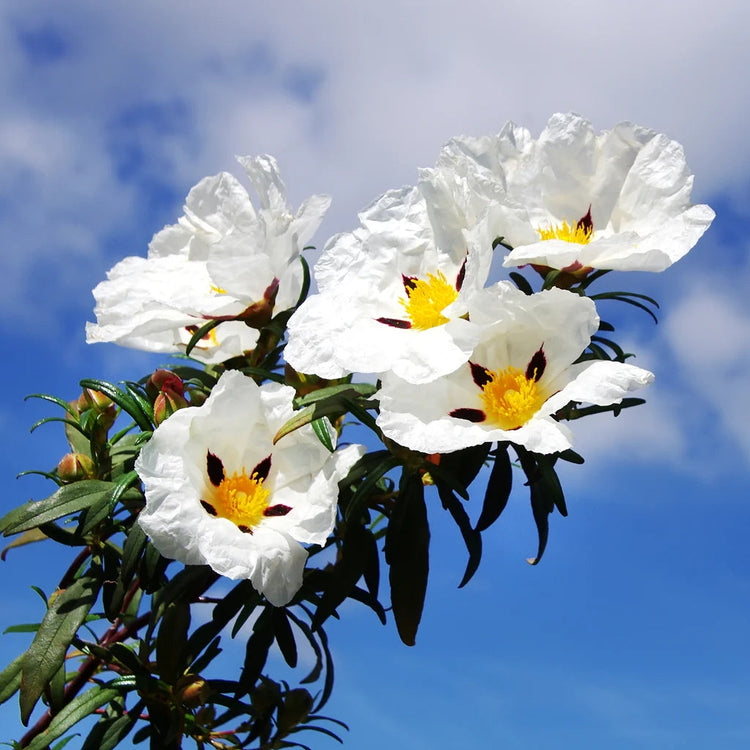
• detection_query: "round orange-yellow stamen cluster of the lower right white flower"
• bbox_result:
[482,367,546,430]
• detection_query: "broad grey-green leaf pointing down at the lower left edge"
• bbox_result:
[20,576,101,724]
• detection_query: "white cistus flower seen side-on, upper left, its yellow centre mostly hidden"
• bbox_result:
[86,156,330,363]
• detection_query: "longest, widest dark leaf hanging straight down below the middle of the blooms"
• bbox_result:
[385,472,430,646]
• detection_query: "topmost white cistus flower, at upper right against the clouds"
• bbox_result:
[423,114,714,276]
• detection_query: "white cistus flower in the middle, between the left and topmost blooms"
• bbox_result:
[285,188,491,383]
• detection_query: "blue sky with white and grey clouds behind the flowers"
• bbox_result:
[0,0,750,750]
